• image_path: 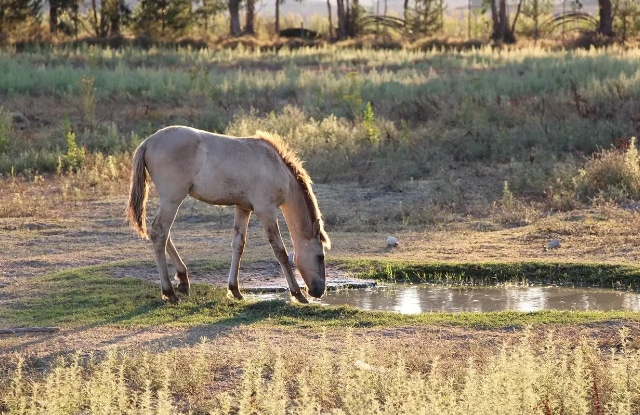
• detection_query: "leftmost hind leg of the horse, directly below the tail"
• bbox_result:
[149,199,182,304]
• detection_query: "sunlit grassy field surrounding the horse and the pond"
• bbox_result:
[0,43,640,415]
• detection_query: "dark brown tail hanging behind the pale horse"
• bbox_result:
[127,141,149,239]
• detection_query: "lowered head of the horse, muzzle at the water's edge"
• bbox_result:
[294,219,329,298]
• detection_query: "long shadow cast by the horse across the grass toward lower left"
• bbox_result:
[3,286,340,370]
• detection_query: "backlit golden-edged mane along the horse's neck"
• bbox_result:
[256,131,331,246]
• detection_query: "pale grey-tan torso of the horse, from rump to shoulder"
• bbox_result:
[145,126,287,210]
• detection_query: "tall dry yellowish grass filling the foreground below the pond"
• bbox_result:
[0,325,640,415]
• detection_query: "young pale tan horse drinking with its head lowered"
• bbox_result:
[126,126,331,304]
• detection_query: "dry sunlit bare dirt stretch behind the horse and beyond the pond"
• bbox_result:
[0,179,640,295]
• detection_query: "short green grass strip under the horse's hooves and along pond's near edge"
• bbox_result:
[0,267,640,328]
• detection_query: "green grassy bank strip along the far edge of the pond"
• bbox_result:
[348,261,640,291]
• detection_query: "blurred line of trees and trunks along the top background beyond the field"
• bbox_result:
[0,0,640,45]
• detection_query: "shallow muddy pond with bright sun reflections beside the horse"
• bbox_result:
[250,284,640,314]
